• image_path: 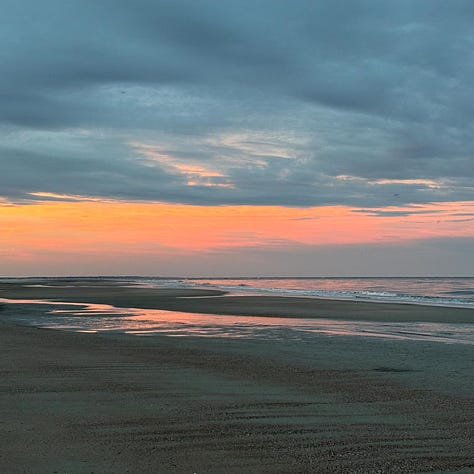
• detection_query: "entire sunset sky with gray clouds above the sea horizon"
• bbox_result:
[0,0,474,276]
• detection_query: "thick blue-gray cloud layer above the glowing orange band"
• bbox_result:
[0,0,474,207]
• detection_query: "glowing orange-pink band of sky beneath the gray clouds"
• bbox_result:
[0,200,474,259]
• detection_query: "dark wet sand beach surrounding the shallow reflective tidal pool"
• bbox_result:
[0,280,474,473]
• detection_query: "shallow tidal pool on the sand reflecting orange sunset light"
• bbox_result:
[0,299,474,345]
